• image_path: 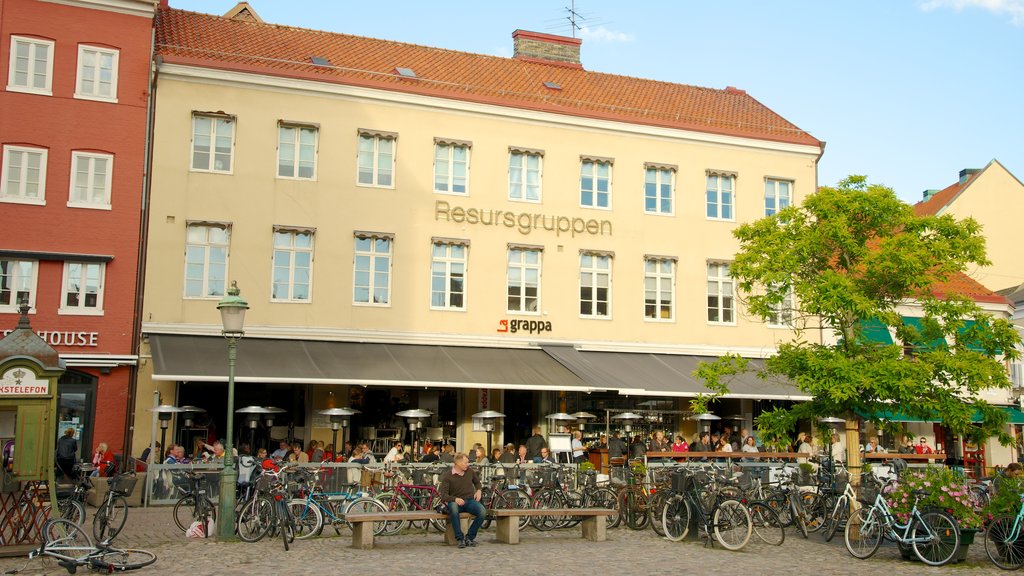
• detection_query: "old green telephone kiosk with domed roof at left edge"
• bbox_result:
[0,305,65,556]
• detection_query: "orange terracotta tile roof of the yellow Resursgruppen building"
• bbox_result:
[156,8,822,147]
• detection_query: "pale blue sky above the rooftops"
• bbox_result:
[163,0,1024,203]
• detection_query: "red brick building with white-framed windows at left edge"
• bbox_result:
[0,0,155,458]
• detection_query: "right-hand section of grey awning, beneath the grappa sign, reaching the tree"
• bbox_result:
[541,345,810,401]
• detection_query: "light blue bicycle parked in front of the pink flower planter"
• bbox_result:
[846,479,959,566]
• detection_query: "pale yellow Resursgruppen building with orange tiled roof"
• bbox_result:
[135,3,824,448]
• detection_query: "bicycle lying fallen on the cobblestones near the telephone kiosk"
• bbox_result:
[6,519,157,574]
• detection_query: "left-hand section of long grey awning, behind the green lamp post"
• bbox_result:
[148,334,594,392]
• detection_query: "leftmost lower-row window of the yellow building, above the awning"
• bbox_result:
[184,222,231,298]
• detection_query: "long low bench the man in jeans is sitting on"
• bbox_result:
[345,508,615,549]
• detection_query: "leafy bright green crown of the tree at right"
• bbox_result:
[712,176,1020,442]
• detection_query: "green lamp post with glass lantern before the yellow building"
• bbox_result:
[217,281,249,540]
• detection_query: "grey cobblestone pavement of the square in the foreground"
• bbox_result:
[0,507,1004,576]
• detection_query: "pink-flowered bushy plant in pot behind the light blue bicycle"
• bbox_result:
[886,466,984,562]
